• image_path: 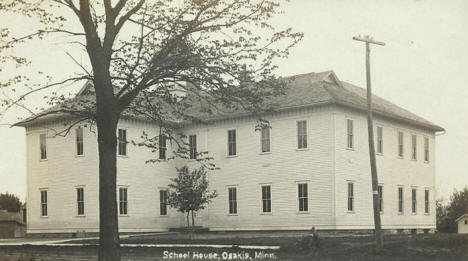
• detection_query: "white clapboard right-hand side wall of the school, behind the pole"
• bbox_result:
[334,105,436,228]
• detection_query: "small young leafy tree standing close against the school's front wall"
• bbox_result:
[168,166,217,227]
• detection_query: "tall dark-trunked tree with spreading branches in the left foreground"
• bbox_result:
[0,0,302,261]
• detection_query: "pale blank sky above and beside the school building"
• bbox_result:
[0,0,468,200]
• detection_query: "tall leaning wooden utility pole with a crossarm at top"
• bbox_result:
[353,35,385,251]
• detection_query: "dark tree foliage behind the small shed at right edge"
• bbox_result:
[436,187,468,233]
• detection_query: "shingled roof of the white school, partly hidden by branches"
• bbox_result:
[16,71,444,131]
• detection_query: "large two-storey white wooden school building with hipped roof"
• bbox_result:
[18,71,444,233]
